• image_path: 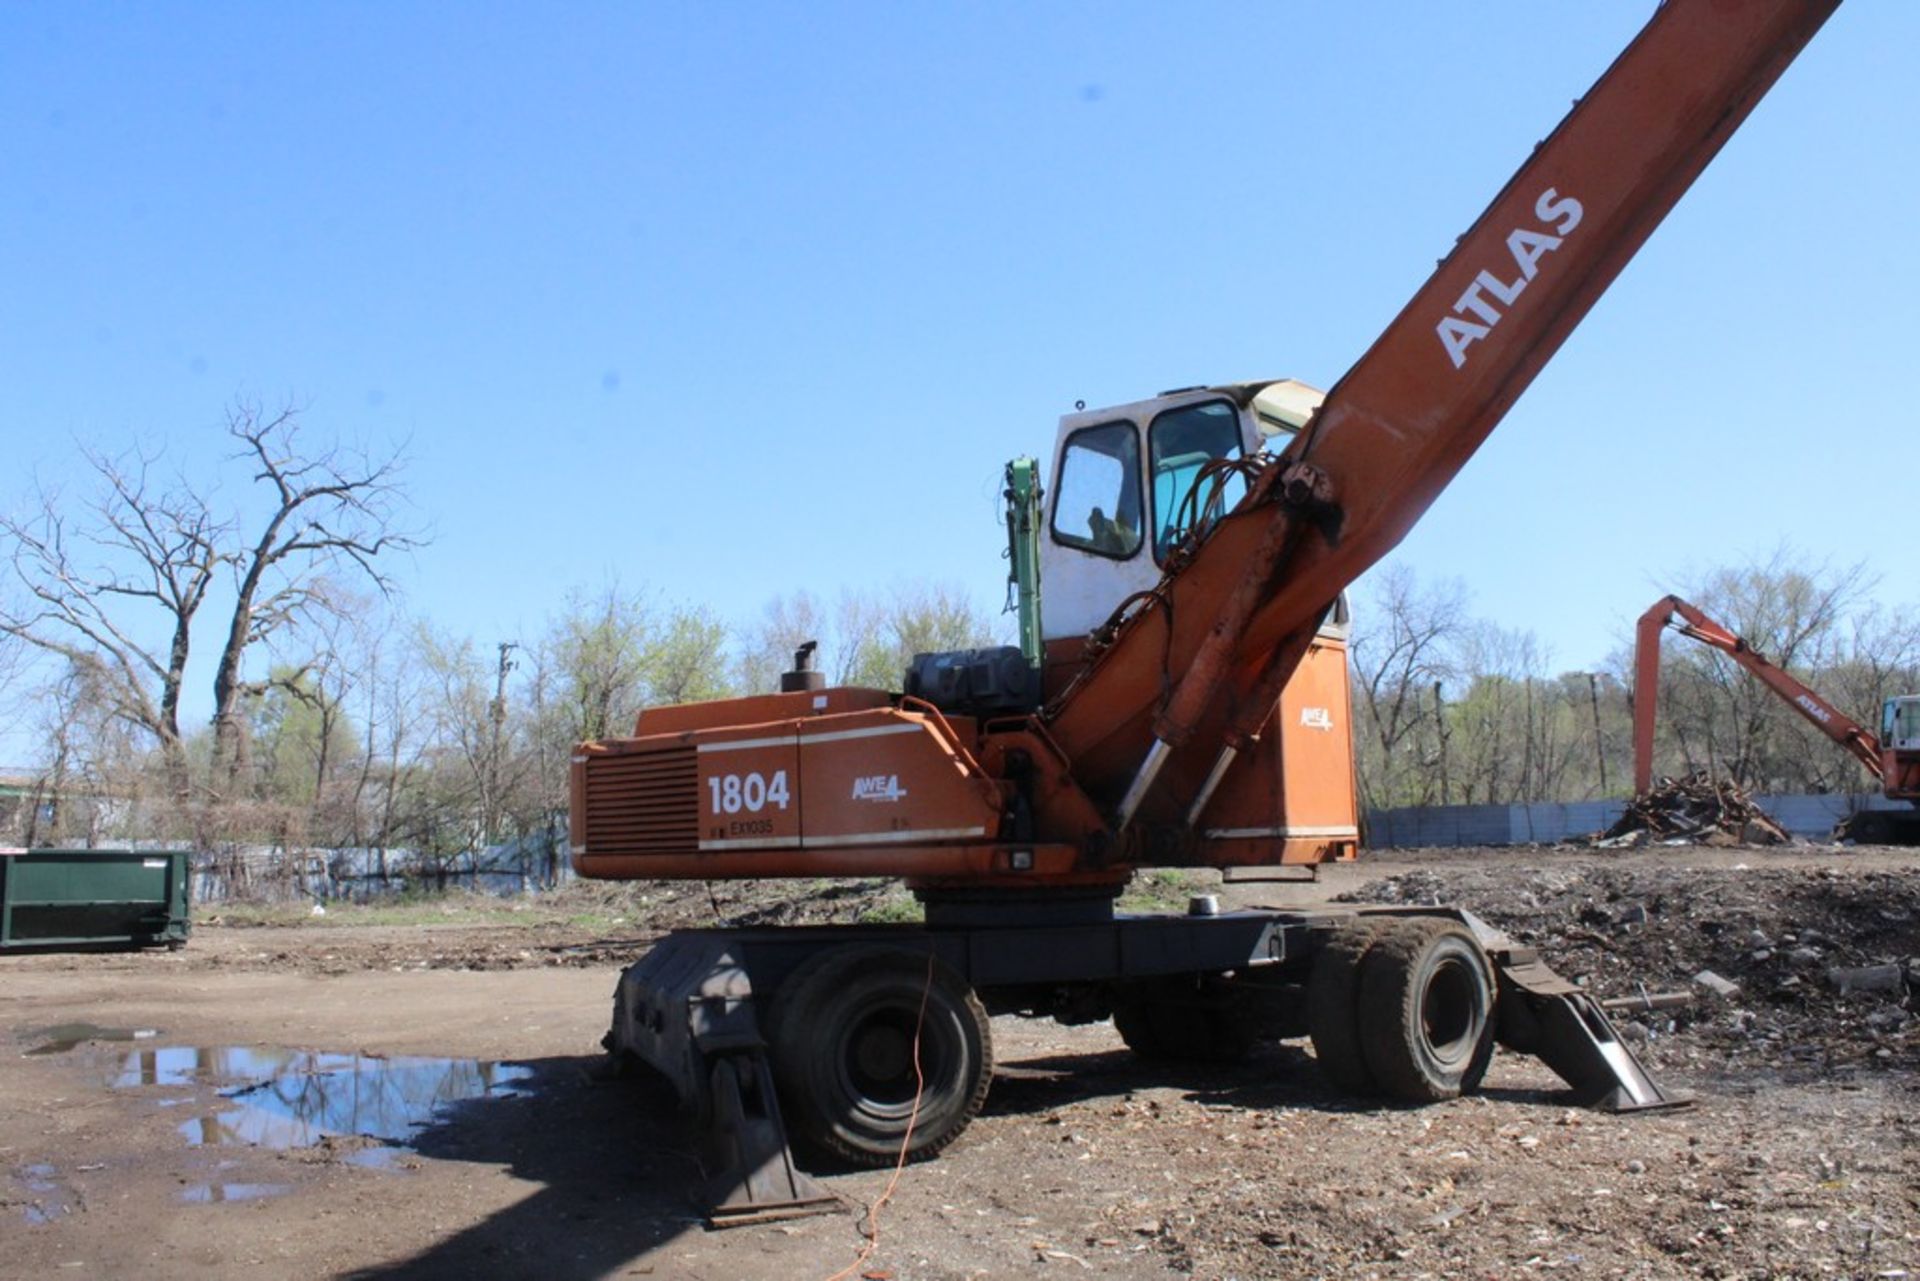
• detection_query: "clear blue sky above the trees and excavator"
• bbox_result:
[0,0,1920,752]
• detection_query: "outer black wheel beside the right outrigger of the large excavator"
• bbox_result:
[1359,920,1494,1102]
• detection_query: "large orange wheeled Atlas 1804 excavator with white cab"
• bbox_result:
[572,0,1837,1221]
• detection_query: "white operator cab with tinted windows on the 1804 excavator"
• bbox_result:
[1041,378,1327,640]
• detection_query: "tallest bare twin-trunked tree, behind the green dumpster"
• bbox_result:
[0,405,419,834]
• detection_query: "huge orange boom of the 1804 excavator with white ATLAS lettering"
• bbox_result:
[1046,0,1837,822]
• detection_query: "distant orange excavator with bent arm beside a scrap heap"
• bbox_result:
[1634,595,1920,845]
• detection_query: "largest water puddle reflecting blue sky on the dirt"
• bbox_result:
[113,1047,534,1170]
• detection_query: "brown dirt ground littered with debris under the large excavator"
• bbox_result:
[0,847,1920,1281]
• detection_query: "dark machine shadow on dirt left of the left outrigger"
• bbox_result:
[342,1056,703,1281]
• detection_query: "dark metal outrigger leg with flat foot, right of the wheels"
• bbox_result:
[1494,949,1693,1112]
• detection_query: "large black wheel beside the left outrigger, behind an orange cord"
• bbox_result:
[768,947,993,1166]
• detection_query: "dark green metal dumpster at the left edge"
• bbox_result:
[0,849,188,951]
